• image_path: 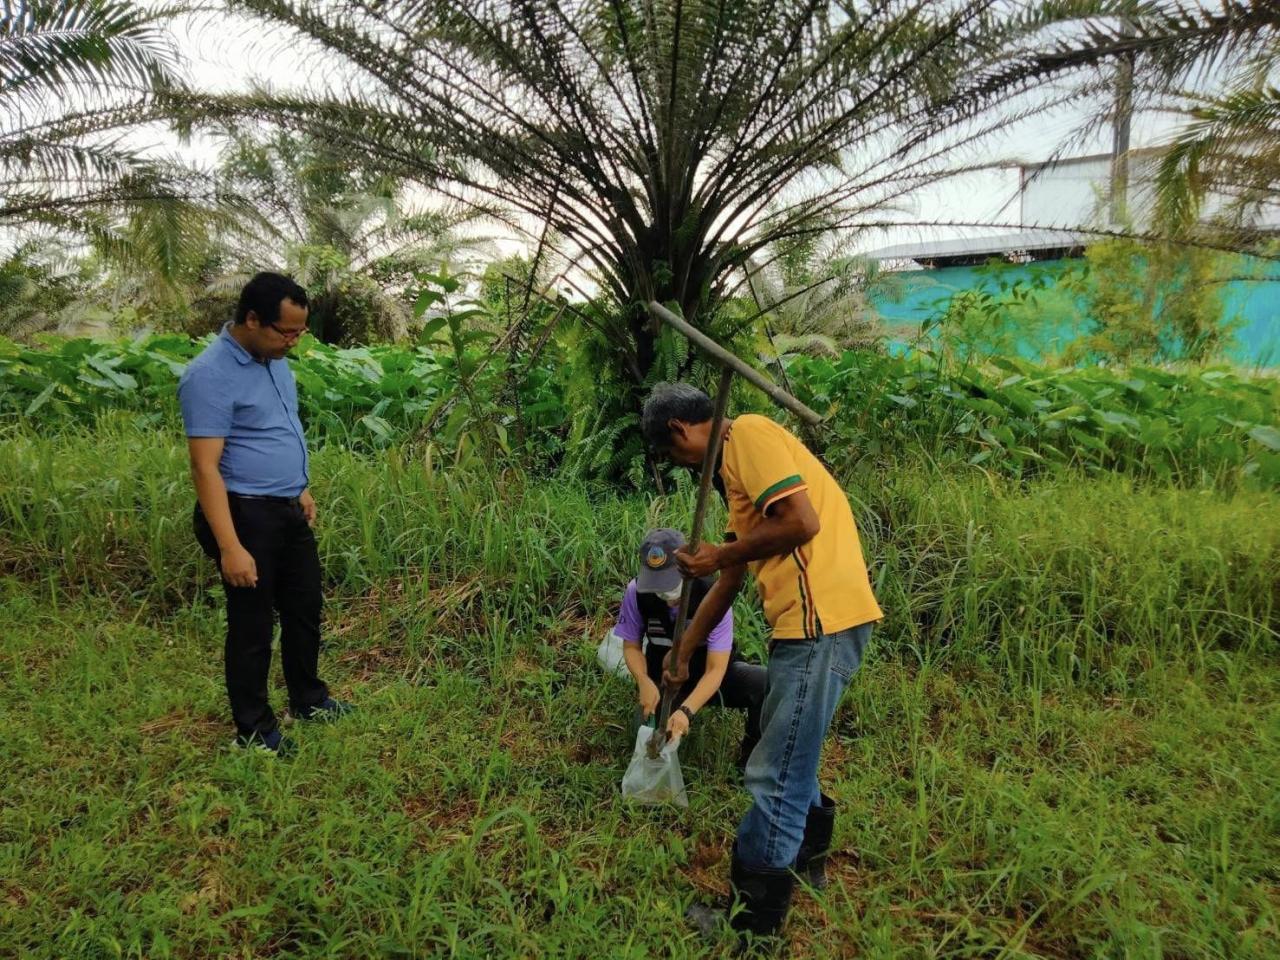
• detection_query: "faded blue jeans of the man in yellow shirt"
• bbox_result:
[737,623,872,869]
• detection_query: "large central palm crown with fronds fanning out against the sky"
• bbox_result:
[177,0,1107,383]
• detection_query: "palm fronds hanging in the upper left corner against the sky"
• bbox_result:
[0,0,258,340]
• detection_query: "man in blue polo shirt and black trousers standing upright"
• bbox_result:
[178,273,351,754]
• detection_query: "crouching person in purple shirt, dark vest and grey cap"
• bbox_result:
[613,529,767,769]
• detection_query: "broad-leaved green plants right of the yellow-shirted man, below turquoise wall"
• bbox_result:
[791,353,1280,484]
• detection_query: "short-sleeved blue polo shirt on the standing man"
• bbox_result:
[178,324,307,497]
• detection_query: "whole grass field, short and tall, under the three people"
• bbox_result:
[0,417,1280,959]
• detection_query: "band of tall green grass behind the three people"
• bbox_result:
[0,417,1280,682]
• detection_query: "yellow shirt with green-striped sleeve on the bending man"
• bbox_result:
[719,413,884,640]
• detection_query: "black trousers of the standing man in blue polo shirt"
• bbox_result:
[195,494,329,736]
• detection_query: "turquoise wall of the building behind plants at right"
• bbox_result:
[873,260,1280,366]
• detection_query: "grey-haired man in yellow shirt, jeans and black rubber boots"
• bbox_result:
[643,384,883,937]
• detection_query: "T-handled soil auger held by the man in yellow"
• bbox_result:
[637,301,822,760]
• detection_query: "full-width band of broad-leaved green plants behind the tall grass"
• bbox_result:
[0,330,1280,486]
